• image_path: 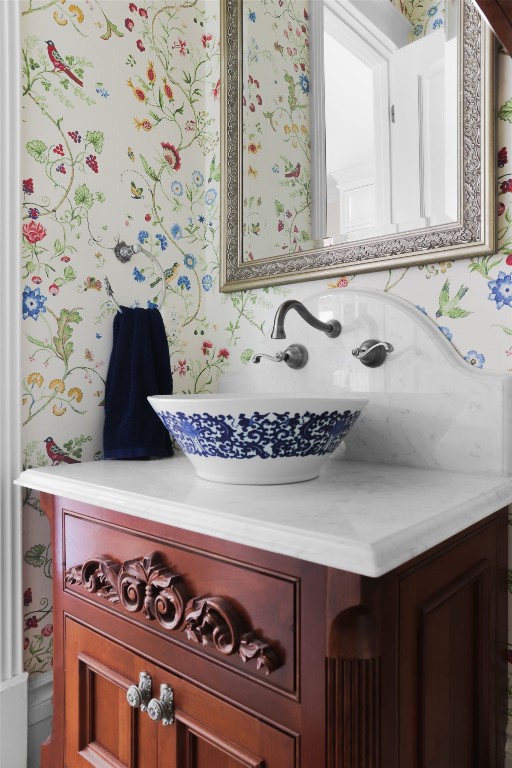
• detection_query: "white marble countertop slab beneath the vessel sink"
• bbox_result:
[16,456,512,576]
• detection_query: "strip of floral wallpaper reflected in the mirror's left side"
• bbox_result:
[242,0,315,260]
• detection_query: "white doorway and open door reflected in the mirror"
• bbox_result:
[318,0,458,243]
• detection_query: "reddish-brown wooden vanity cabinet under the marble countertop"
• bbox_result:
[42,494,507,768]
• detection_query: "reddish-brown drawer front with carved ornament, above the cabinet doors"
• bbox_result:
[63,510,300,695]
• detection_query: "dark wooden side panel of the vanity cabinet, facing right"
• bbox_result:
[399,527,506,768]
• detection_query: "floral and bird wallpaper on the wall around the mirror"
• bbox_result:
[20,0,512,704]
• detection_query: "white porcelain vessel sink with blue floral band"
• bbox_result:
[148,394,368,485]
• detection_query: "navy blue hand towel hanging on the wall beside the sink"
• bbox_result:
[103,307,173,459]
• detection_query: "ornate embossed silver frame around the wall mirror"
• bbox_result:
[220,0,496,292]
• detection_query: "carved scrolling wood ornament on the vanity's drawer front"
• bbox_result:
[65,552,281,675]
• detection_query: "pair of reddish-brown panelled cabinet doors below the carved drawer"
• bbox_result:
[65,619,296,768]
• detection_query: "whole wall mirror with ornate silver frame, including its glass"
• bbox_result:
[220,0,496,291]
